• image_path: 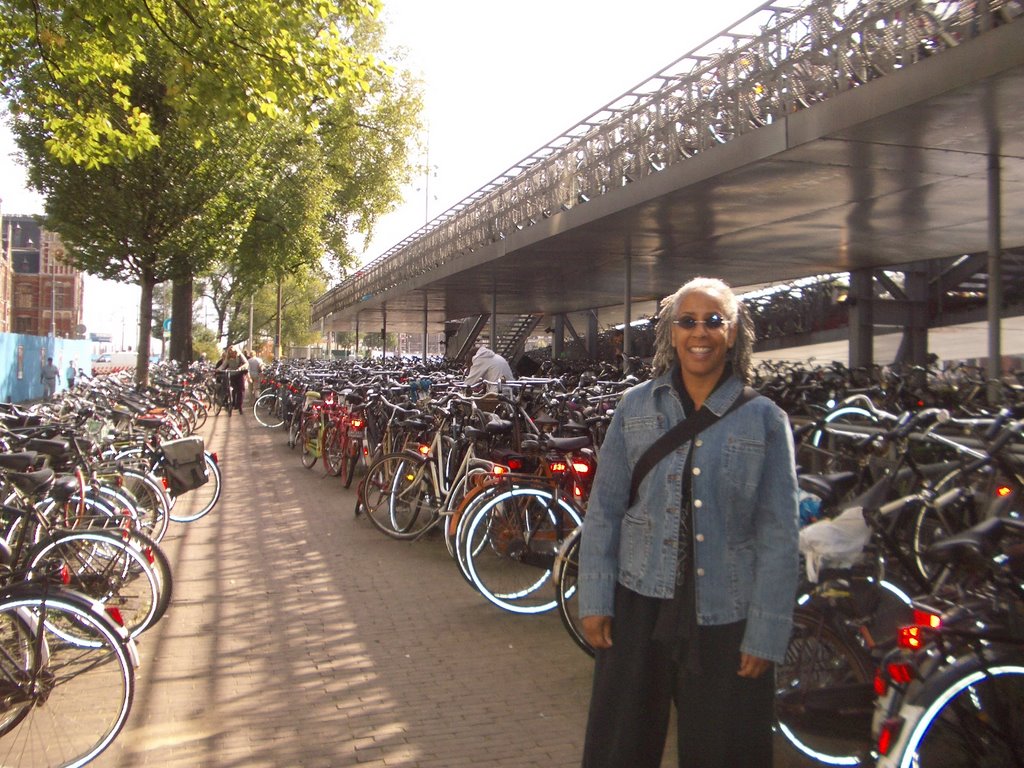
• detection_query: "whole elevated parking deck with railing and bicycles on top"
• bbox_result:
[313,0,1024,376]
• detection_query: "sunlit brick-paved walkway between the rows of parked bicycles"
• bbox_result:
[94,415,815,768]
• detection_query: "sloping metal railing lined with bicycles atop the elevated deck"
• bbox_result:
[312,0,1024,319]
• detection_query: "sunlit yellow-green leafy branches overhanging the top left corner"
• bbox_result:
[0,0,388,168]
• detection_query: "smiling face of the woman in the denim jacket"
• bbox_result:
[672,291,737,383]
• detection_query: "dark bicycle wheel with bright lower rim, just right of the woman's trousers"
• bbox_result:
[775,609,872,766]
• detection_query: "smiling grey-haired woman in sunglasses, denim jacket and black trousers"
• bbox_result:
[579,278,799,768]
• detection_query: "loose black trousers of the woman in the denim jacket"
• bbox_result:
[583,586,775,768]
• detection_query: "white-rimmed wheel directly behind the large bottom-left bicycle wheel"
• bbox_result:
[29,531,163,639]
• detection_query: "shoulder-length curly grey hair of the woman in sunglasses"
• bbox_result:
[651,278,754,384]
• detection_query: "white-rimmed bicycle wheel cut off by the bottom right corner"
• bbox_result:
[901,658,1024,768]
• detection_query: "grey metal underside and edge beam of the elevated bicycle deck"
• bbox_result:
[328,23,1024,333]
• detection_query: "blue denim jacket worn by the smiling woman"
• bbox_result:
[579,374,799,662]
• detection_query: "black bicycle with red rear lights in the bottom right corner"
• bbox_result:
[874,518,1024,768]
